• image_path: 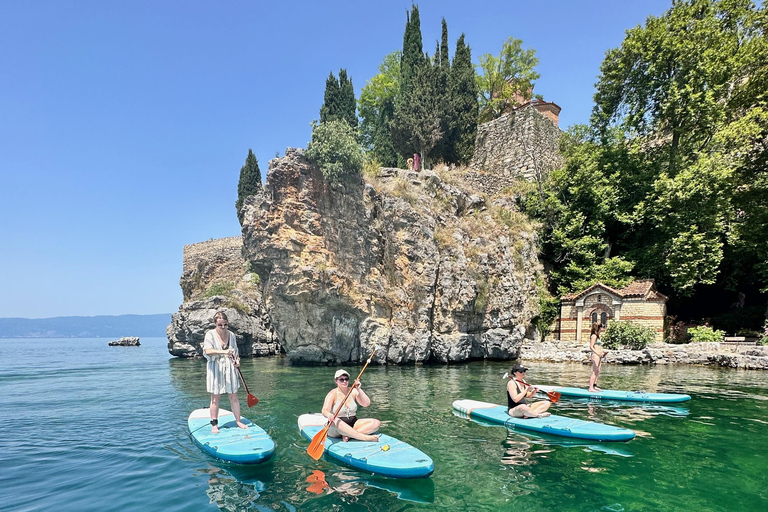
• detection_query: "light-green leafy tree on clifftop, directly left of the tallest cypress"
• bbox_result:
[358,51,401,167]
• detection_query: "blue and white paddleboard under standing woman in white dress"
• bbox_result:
[187,409,275,464]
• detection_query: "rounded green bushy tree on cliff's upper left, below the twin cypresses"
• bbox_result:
[306,120,364,182]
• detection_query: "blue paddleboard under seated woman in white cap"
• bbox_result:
[299,414,435,478]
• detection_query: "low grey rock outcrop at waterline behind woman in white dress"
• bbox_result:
[166,290,280,357]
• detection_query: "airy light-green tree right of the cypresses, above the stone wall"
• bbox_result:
[476,37,540,122]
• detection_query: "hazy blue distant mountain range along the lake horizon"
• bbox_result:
[0,313,171,338]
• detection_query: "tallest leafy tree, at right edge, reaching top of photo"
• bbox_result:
[593,0,768,295]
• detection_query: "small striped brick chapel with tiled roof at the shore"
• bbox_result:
[552,279,667,343]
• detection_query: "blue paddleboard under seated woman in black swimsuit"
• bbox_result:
[453,400,635,441]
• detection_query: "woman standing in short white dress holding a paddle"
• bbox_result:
[203,311,248,434]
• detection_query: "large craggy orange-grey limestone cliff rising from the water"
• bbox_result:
[238,148,541,363]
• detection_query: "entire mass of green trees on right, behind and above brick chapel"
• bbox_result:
[526,0,768,328]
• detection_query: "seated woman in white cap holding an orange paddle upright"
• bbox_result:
[323,370,381,441]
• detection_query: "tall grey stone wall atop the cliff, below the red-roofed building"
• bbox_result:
[469,106,563,182]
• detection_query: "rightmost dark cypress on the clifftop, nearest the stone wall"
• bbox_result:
[448,34,479,164]
